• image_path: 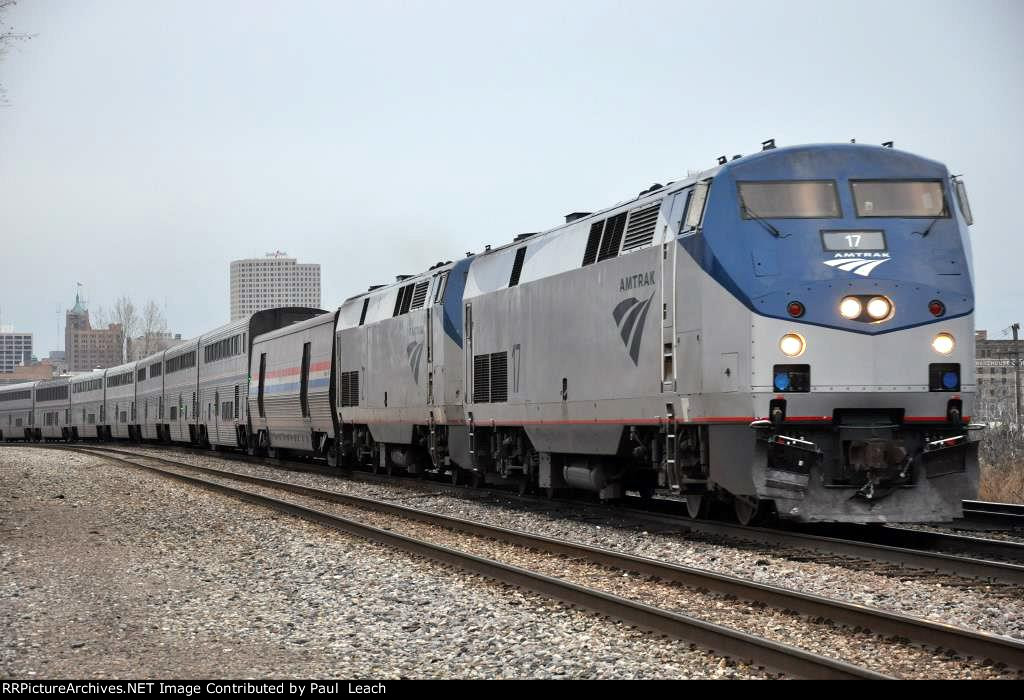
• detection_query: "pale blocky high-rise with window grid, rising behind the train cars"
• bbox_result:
[230,251,321,320]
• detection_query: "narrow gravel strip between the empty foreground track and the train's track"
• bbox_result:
[116,449,1024,640]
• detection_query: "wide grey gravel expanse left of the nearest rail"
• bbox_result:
[0,446,766,679]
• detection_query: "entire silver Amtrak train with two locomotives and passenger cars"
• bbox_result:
[0,141,981,524]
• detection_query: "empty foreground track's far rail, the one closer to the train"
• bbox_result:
[66,447,1024,668]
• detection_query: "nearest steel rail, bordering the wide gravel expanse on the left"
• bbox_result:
[54,447,891,680]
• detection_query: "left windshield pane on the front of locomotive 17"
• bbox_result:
[739,180,842,219]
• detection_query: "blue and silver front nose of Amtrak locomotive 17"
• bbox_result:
[680,144,977,521]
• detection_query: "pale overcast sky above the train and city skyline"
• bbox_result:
[0,0,1024,356]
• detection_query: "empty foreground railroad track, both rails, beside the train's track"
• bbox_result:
[24,447,1024,677]
